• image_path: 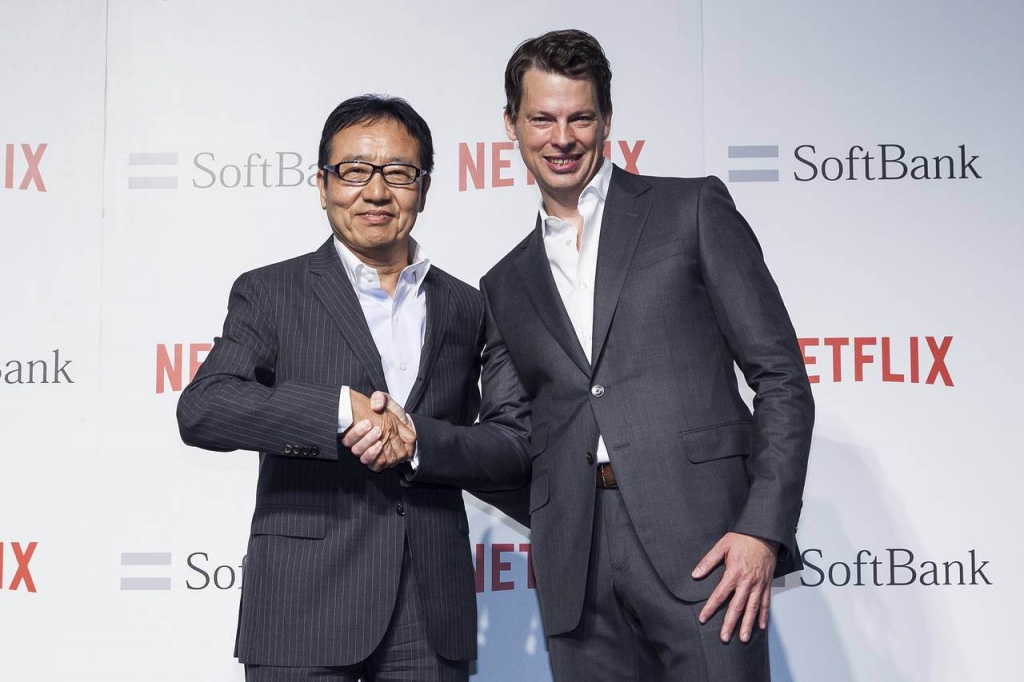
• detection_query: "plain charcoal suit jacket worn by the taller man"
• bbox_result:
[481,168,814,636]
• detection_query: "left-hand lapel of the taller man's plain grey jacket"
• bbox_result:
[515,220,590,376]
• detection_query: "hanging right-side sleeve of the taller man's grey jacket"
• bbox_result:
[697,177,814,556]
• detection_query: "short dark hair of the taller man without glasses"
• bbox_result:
[505,29,611,120]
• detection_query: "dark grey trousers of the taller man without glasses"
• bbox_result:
[542,488,769,682]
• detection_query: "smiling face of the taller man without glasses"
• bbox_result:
[505,69,611,215]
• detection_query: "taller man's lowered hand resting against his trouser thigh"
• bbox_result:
[692,532,778,643]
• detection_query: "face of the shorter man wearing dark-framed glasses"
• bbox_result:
[316,119,430,266]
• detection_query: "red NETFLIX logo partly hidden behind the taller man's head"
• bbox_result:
[459,139,645,191]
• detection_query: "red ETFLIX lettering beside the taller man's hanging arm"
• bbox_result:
[798,336,953,386]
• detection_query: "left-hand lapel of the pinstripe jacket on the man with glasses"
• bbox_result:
[309,237,387,391]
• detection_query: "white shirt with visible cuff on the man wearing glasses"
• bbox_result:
[334,237,430,433]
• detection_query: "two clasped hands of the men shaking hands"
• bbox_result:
[341,389,416,473]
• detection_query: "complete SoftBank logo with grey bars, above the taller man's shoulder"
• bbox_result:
[728,142,982,182]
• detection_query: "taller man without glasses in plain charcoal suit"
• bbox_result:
[349,31,814,682]
